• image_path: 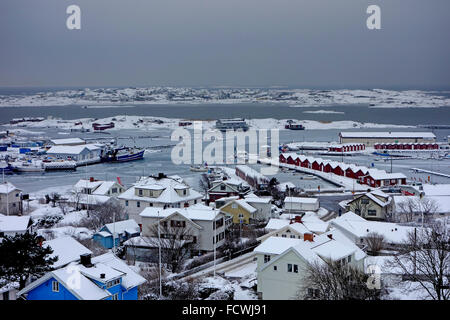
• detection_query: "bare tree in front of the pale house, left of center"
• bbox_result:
[144,221,197,272]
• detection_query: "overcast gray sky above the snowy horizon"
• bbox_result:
[0,0,450,88]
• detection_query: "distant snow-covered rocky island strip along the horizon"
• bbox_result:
[0,87,450,108]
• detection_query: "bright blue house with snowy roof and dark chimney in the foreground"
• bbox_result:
[18,253,146,300]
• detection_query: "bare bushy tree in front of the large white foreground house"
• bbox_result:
[296,262,382,300]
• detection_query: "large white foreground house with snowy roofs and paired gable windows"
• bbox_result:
[254,230,366,300]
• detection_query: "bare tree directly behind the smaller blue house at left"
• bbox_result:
[80,199,128,230]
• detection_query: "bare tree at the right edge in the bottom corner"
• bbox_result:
[389,223,450,300]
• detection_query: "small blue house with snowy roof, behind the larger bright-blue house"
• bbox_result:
[92,219,141,249]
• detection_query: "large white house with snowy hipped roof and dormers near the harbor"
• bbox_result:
[118,174,203,223]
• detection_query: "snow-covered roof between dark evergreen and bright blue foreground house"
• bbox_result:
[42,237,92,268]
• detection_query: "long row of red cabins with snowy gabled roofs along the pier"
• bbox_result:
[279,153,406,187]
